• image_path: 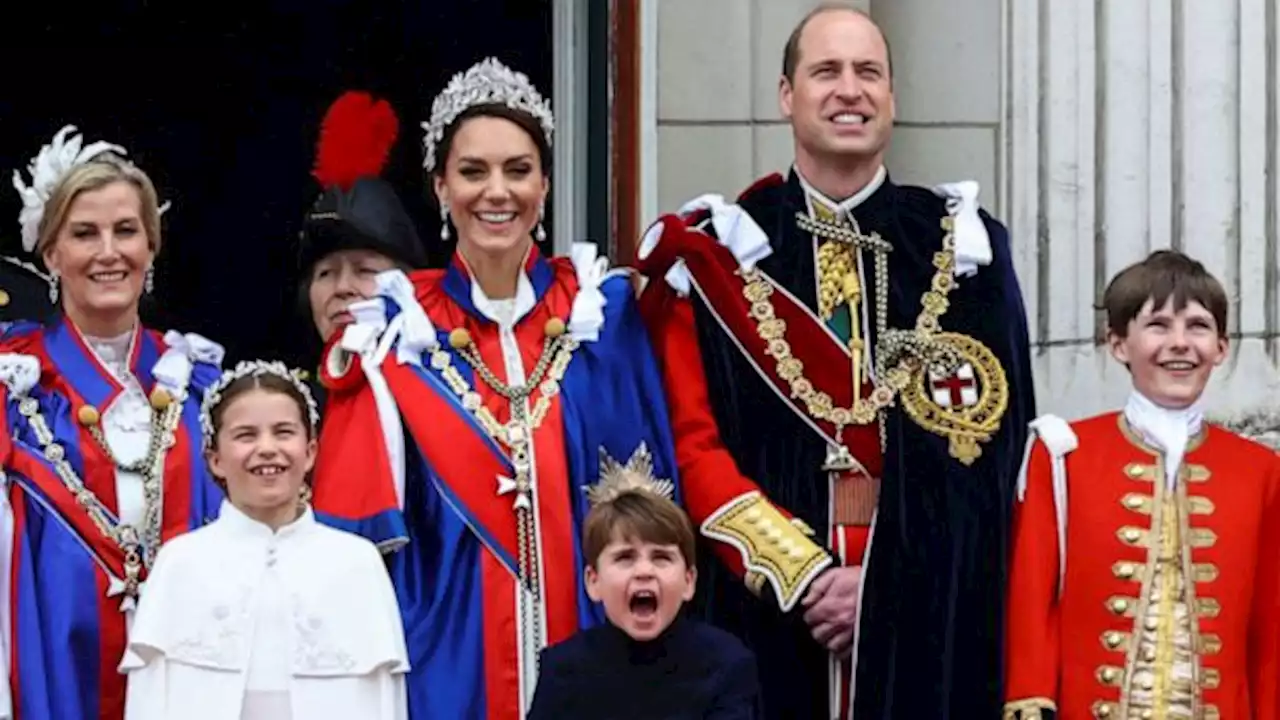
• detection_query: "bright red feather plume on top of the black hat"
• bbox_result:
[311,91,399,190]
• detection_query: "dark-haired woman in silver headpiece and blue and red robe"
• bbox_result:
[315,59,678,720]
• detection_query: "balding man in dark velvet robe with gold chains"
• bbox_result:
[640,6,1034,720]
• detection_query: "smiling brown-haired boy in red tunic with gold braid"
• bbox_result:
[1005,251,1280,720]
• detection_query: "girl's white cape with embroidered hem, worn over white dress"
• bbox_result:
[120,503,408,720]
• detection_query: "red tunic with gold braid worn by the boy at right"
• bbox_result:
[1005,413,1280,720]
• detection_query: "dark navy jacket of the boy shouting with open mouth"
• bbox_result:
[529,609,760,720]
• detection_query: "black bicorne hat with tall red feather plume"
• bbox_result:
[298,91,426,278]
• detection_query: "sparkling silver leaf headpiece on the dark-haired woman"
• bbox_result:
[422,58,556,173]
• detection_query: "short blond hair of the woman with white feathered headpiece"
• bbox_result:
[36,152,160,256]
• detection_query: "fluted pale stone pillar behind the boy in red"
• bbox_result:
[1001,0,1280,427]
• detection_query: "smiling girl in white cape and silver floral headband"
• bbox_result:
[122,360,408,720]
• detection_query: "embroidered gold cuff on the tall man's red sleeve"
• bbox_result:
[701,492,831,610]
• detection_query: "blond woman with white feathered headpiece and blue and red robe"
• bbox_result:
[0,127,223,720]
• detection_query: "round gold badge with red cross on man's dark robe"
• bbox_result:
[901,332,1009,465]
